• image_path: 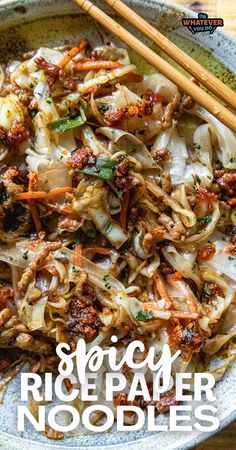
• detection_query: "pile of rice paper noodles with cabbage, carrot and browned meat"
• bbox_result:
[0,40,236,437]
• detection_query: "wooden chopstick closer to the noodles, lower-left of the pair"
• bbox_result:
[75,0,236,132]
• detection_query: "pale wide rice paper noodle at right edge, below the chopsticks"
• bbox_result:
[192,106,236,169]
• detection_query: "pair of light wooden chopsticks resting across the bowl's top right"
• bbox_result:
[75,0,236,132]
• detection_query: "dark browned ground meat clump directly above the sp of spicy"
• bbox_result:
[68,296,102,340]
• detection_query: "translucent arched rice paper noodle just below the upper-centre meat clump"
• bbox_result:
[97,127,156,169]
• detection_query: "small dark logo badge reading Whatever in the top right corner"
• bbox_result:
[182,13,224,34]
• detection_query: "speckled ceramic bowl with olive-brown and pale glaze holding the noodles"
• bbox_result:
[0,0,236,450]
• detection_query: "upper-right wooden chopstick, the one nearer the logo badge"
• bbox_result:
[105,0,236,109]
